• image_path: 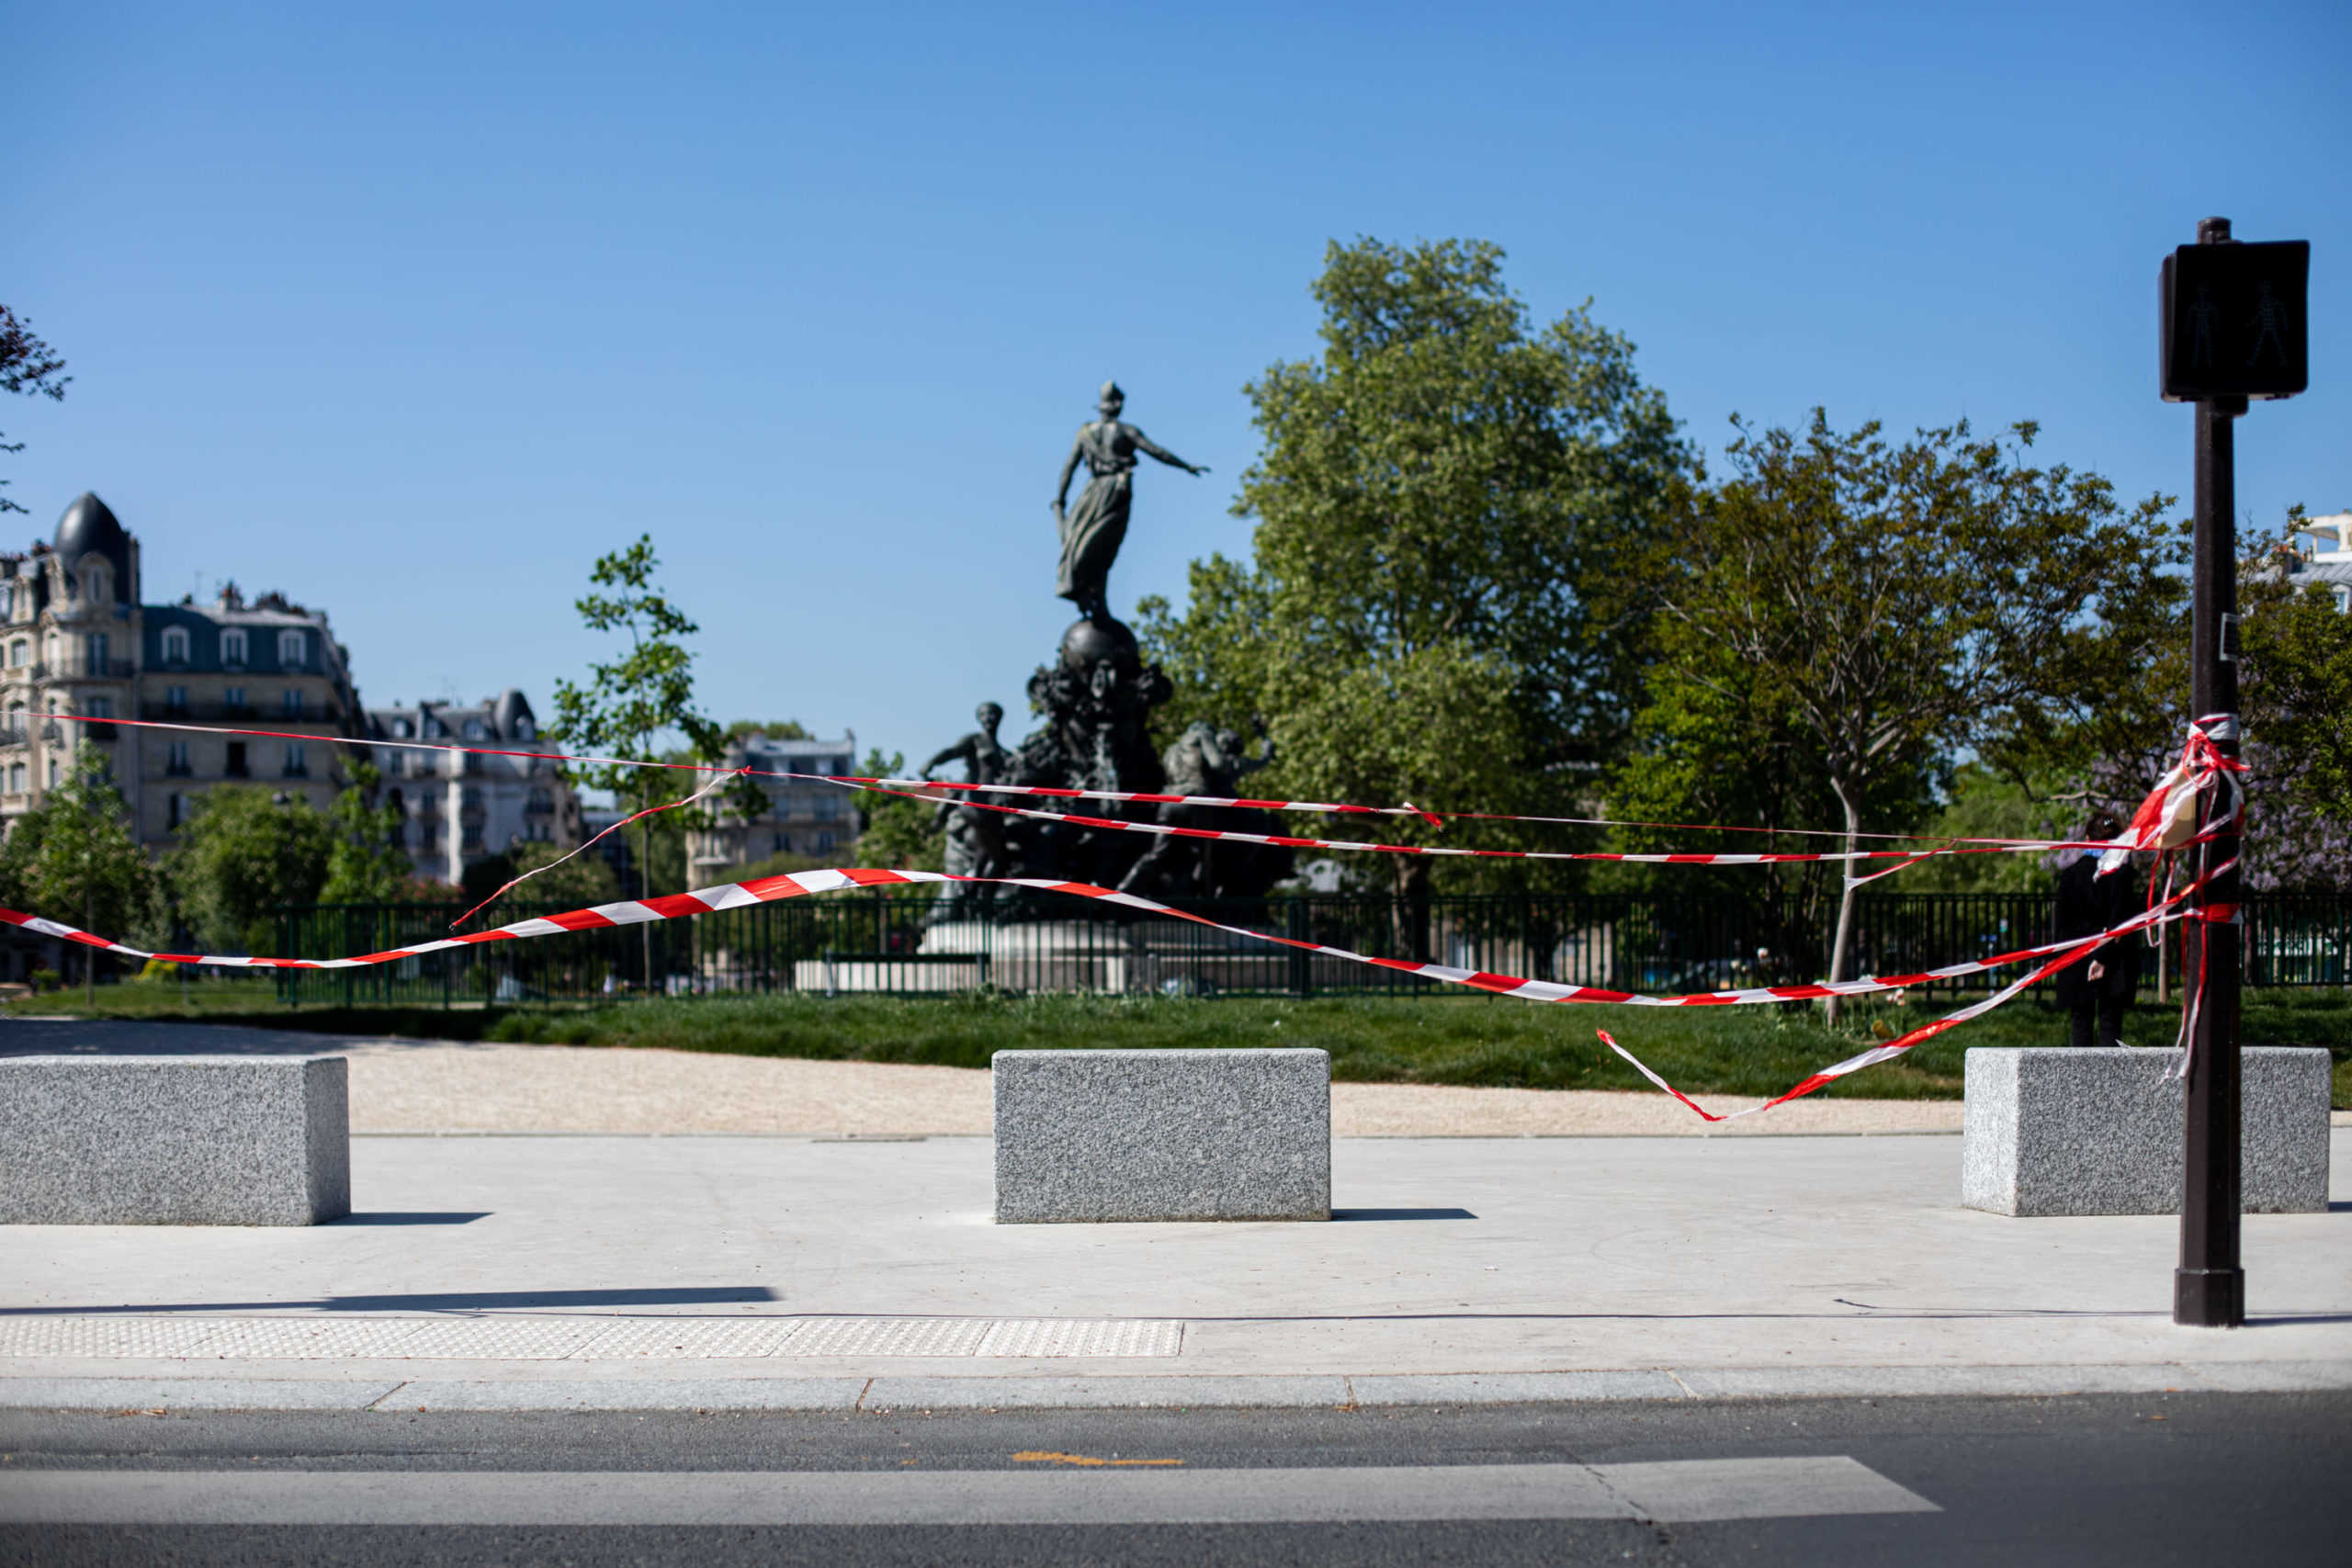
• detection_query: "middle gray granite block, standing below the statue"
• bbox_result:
[992,1051,1331,1224]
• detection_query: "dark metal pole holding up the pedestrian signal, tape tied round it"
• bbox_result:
[2173,219,2246,1328]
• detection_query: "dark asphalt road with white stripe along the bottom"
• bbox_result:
[0,1394,2352,1568]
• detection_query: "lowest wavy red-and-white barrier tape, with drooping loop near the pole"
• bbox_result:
[0,863,2201,1122]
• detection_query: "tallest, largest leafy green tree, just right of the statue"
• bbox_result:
[1141,240,1687,898]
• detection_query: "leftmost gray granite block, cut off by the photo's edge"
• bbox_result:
[0,1055,350,1224]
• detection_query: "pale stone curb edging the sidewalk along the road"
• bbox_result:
[0,1361,2352,1416]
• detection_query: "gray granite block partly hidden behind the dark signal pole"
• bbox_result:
[1959,1046,2331,1215]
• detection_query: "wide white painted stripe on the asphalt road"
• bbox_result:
[0,1455,1938,1526]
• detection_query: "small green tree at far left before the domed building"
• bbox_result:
[0,771,158,999]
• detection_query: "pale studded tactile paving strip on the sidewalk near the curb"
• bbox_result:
[0,1316,1183,1361]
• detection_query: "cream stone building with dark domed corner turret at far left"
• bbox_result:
[0,493,362,853]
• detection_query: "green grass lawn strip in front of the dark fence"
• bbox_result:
[0,980,2352,1110]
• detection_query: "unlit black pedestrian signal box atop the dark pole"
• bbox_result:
[2157,240,2312,402]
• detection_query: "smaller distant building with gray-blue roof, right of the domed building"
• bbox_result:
[367,686,583,882]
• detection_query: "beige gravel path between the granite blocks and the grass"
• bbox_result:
[336,1043,1959,1138]
